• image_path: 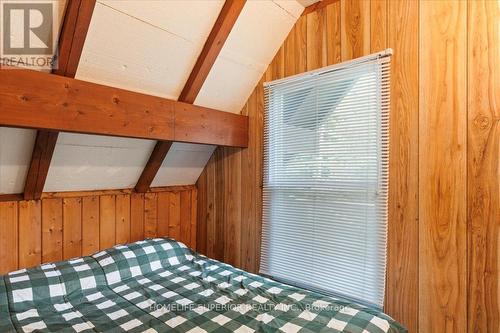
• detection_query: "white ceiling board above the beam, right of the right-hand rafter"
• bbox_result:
[195,0,304,113]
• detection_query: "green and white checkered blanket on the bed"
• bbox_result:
[0,238,406,333]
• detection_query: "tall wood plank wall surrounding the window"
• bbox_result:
[197,0,500,333]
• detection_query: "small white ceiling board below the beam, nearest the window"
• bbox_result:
[151,143,215,186]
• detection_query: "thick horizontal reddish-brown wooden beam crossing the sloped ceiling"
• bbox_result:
[0,69,248,147]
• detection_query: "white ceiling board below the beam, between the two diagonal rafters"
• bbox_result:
[44,133,155,192]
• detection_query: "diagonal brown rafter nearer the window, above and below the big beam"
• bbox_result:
[135,0,246,193]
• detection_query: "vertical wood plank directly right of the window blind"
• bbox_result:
[384,0,419,332]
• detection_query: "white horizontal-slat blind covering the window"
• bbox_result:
[260,50,391,308]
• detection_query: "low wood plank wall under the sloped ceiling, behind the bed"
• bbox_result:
[0,186,197,275]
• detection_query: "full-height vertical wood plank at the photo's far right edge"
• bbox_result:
[467,0,500,333]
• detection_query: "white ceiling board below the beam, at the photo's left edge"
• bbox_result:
[0,127,36,194]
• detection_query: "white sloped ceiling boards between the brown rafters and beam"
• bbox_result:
[0,0,304,193]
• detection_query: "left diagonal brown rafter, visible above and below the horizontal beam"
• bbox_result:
[24,0,95,200]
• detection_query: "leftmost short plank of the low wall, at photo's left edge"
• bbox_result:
[0,202,19,275]
